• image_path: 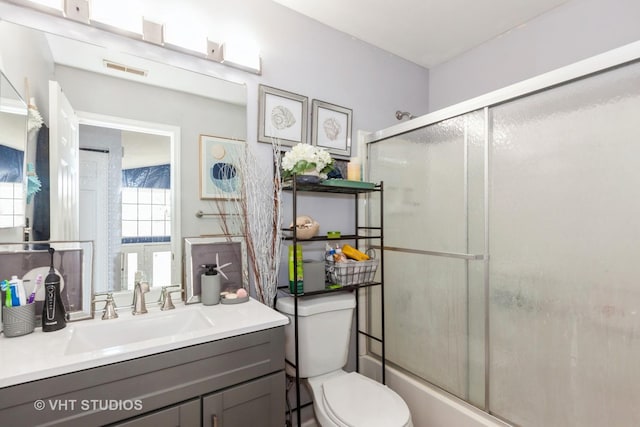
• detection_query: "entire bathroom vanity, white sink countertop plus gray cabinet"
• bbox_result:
[0,300,288,427]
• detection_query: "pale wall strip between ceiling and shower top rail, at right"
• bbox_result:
[429,0,640,111]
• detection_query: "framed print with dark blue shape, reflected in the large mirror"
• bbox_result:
[200,135,246,200]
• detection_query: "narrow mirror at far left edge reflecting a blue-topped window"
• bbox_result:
[0,72,27,228]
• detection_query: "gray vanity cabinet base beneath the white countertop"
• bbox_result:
[0,326,285,427]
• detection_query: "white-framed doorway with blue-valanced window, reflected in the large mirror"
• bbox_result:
[78,118,180,292]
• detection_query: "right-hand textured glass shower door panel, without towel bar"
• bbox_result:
[489,64,640,427]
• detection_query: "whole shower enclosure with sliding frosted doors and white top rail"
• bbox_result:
[366,44,640,427]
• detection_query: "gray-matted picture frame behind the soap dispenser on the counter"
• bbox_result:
[184,236,249,304]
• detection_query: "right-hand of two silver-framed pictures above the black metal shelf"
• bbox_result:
[311,99,353,157]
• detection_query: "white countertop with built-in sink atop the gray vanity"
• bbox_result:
[0,299,289,388]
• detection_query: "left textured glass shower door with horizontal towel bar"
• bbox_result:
[369,111,484,406]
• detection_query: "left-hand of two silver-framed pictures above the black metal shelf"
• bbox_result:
[258,85,309,147]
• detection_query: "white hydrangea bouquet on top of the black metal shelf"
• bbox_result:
[281,143,333,179]
